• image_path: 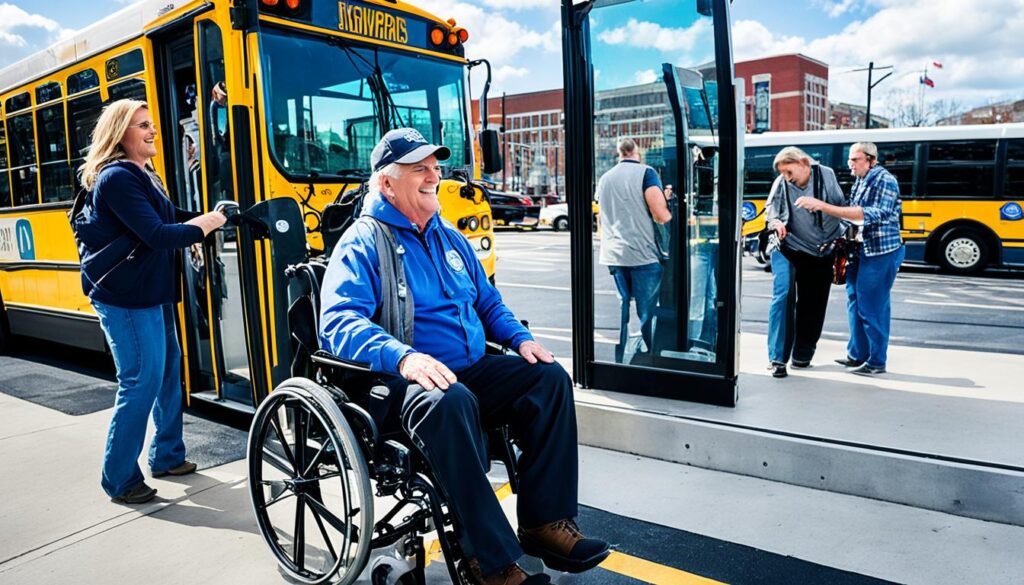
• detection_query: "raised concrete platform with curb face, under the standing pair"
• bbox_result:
[577,334,1024,525]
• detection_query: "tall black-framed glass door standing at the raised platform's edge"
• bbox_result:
[562,0,741,406]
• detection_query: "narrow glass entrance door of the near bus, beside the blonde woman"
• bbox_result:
[153,16,276,411]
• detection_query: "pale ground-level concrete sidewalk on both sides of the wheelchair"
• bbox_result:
[0,377,1024,585]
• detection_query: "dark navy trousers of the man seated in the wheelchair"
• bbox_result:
[370,356,579,575]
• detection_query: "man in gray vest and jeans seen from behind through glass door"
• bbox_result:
[597,138,672,363]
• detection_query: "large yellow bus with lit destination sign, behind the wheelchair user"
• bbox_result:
[0,0,495,410]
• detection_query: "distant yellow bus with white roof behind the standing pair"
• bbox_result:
[742,124,1024,274]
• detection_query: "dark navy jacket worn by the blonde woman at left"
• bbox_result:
[78,161,203,308]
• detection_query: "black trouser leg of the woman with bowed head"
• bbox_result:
[782,245,833,362]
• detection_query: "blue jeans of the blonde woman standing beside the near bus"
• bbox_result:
[92,300,185,498]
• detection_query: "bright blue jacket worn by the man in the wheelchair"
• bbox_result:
[319,194,534,375]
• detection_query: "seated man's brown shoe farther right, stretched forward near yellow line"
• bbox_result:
[519,518,611,573]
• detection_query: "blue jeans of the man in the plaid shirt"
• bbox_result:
[846,246,906,368]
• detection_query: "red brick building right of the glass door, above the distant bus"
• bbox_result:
[735,53,828,132]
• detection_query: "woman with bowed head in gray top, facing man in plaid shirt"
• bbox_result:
[765,147,846,378]
